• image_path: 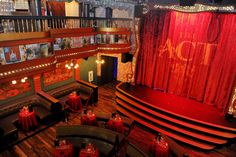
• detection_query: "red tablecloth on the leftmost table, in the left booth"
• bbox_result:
[19,109,38,130]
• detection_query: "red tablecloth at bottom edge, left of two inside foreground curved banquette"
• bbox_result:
[53,144,73,157]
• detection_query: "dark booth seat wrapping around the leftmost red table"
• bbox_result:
[0,95,62,143]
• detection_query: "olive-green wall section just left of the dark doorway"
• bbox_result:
[80,57,98,84]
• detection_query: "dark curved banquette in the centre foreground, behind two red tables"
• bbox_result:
[56,125,125,156]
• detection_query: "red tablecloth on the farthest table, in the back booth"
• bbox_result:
[68,93,82,111]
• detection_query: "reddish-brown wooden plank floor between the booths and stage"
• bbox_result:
[0,82,236,157]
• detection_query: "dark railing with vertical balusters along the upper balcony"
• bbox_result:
[0,16,133,33]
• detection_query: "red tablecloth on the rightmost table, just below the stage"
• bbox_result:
[150,138,169,157]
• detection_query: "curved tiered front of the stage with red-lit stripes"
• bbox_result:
[116,83,236,150]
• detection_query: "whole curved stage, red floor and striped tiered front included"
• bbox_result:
[116,83,236,150]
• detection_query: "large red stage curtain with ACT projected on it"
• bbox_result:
[136,11,236,109]
